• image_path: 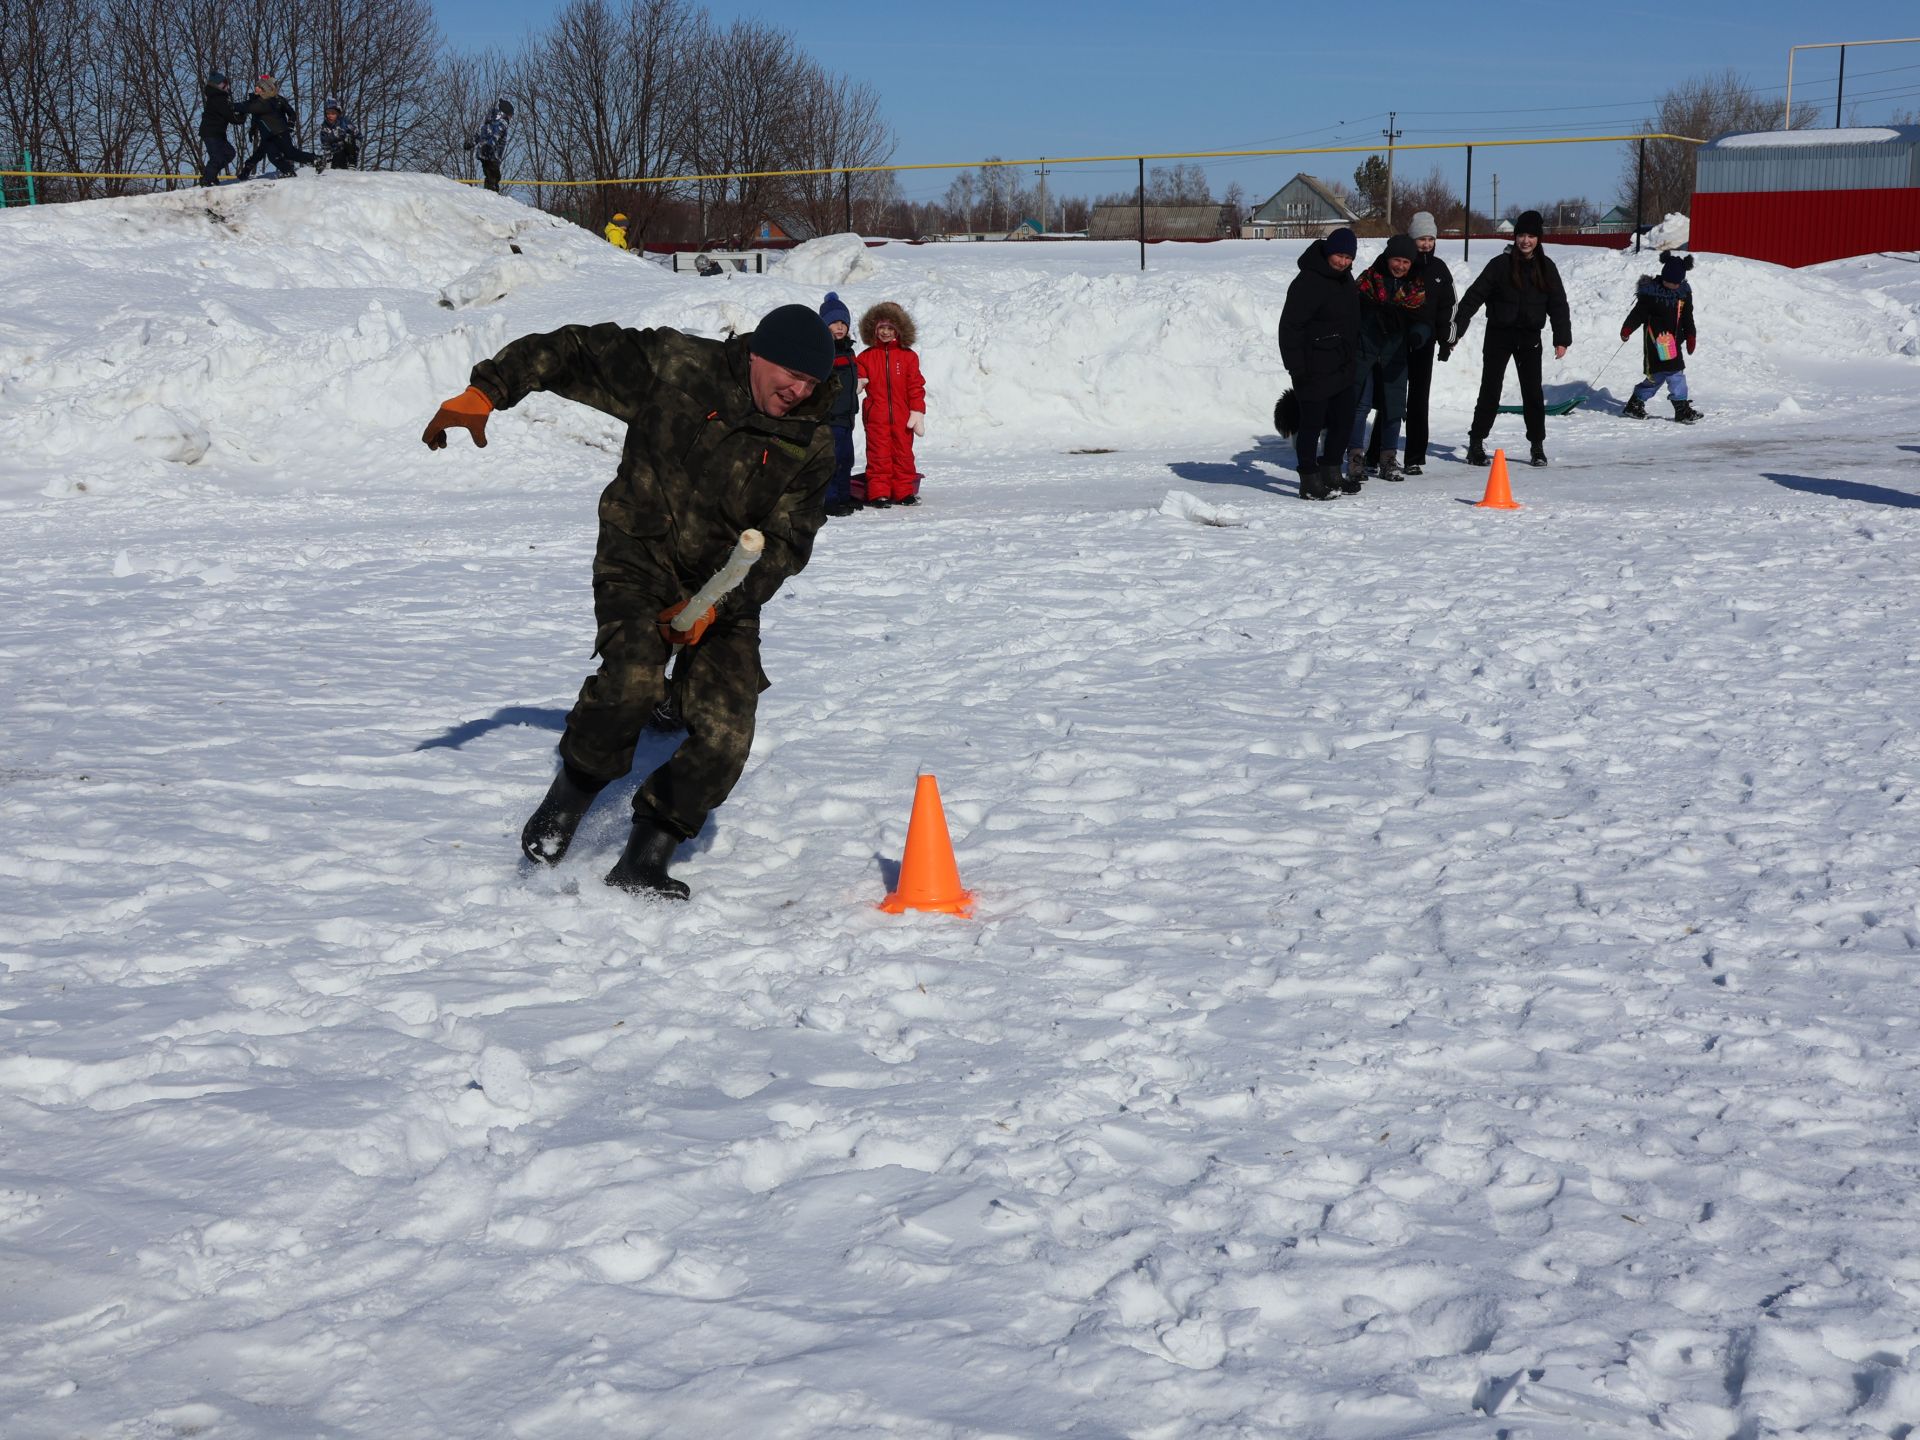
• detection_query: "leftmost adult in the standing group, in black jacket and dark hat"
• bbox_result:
[1281,225,1359,499]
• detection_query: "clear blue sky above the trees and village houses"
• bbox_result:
[442,0,1920,207]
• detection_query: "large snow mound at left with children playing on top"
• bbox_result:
[0,175,660,493]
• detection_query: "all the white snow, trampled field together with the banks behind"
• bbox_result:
[0,175,1920,1440]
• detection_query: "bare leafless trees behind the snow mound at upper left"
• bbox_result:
[0,0,895,240]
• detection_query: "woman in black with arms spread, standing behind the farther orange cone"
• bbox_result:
[1448,209,1572,465]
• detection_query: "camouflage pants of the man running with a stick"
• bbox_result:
[561,586,766,839]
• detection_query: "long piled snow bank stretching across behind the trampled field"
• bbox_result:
[0,175,1920,503]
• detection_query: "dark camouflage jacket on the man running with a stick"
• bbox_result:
[472,323,833,620]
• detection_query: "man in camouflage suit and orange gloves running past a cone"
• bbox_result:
[422,305,833,899]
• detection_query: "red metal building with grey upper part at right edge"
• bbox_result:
[1688,125,1920,265]
